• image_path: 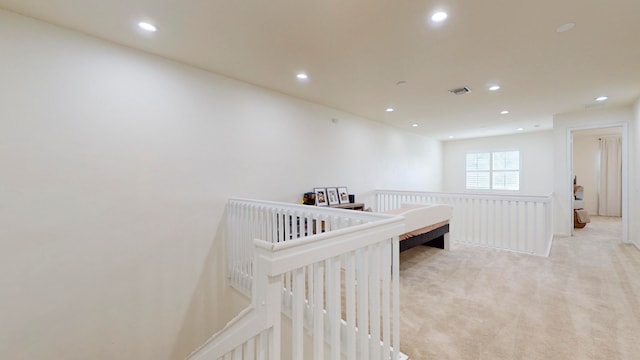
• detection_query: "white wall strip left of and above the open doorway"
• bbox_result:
[553,106,633,236]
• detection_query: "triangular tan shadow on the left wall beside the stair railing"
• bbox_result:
[170,209,249,360]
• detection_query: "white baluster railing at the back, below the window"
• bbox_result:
[375,190,553,256]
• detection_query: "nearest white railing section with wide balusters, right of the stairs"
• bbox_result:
[256,217,404,360]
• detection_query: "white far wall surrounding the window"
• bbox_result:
[443,131,554,195]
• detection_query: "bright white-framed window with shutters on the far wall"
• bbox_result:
[465,150,522,192]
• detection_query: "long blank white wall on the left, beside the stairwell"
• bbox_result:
[0,11,442,360]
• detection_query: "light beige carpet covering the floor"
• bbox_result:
[400,216,640,360]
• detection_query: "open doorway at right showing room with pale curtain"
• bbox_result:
[570,125,628,242]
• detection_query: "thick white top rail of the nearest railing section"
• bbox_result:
[254,216,405,276]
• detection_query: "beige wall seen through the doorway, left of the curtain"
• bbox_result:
[573,132,600,215]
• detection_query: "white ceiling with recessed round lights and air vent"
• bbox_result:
[0,0,640,140]
